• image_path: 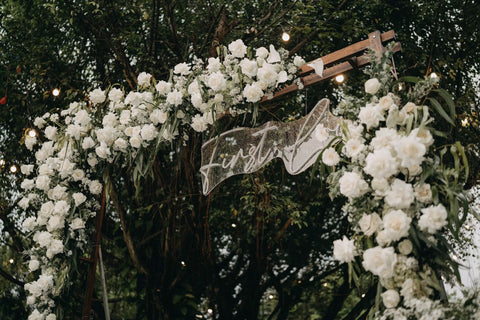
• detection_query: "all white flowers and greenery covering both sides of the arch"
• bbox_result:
[19,40,468,320]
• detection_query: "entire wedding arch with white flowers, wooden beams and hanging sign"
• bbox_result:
[19,31,468,320]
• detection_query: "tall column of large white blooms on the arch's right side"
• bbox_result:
[333,78,447,319]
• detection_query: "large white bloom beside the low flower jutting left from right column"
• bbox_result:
[362,247,397,279]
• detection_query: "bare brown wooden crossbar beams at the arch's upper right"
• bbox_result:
[262,30,402,102]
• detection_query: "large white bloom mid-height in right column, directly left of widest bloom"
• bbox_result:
[363,148,398,179]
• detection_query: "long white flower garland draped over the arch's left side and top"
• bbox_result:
[19,40,305,320]
